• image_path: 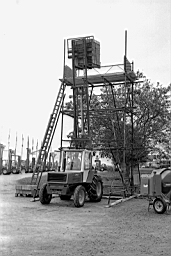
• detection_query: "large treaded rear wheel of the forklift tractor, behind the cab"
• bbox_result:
[88,175,103,202]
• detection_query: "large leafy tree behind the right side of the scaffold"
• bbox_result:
[65,72,171,164]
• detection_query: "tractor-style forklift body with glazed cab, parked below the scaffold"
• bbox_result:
[39,149,103,207]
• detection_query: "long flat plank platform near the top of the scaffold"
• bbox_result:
[60,71,137,87]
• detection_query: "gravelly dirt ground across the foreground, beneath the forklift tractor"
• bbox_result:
[0,174,171,256]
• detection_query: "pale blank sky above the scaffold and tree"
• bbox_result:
[0,0,171,159]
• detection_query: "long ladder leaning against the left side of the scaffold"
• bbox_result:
[31,81,66,191]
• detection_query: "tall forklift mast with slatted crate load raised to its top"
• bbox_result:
[67,36,100,149]
